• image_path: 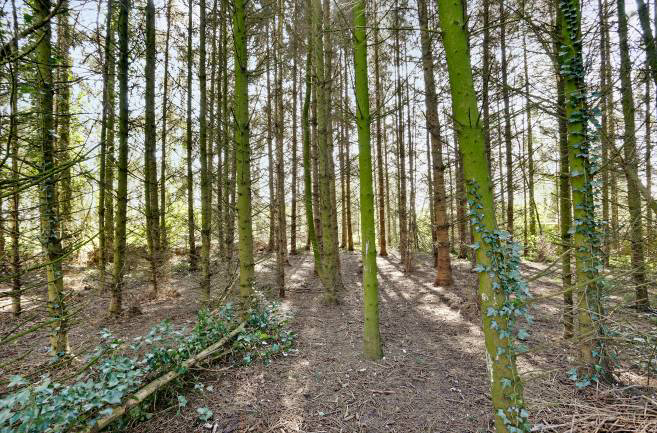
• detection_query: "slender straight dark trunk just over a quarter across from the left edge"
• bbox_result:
[185,1,198,271]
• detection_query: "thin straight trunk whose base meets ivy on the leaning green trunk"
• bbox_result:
[500,0,514,235]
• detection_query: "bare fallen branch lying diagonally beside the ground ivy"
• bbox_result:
[86,321,246,433]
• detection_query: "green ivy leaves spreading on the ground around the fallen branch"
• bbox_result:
[0,304,294,433]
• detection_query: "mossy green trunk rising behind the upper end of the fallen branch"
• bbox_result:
[233,0,255,300]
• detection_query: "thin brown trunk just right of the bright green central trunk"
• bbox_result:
[374,0,388,257]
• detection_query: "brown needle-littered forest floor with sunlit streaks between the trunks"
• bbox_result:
[0,248,657,433]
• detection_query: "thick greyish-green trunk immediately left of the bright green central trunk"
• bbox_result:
[311,0,342,303]
